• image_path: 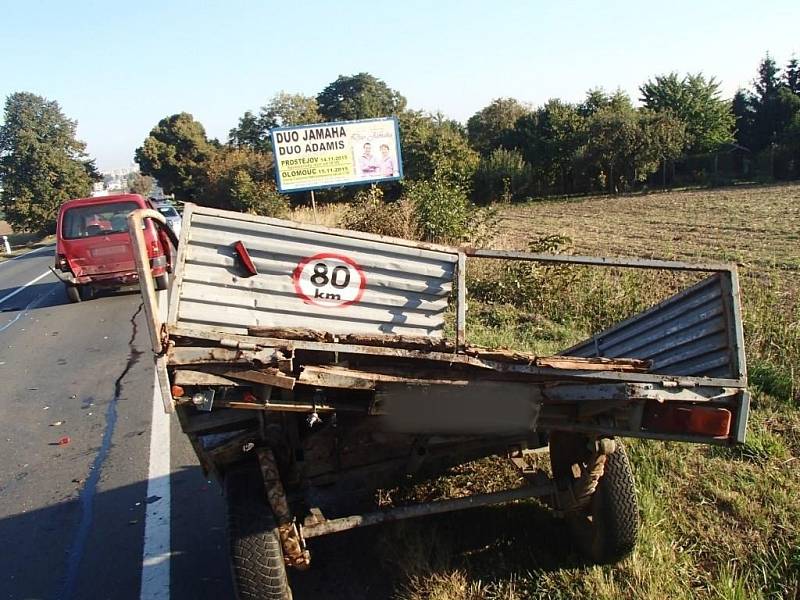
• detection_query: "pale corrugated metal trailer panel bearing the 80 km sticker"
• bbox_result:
[170,207,458,337]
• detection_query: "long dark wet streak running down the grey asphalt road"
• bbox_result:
[58,304,144,600]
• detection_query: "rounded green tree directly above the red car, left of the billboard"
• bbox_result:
[135,112,219,202]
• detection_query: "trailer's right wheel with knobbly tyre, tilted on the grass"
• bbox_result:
[550,432,639,564]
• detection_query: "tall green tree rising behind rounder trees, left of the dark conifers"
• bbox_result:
[639,73,736,154]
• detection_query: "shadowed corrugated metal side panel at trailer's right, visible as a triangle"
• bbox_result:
[564,273,739,379]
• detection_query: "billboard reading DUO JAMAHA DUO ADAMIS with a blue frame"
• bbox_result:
[270,117,403,192]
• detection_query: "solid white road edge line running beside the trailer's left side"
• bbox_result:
[139,292,172,600]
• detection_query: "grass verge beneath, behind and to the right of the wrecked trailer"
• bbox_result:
[393,211,800,600]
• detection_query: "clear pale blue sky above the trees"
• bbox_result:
[0,0,800,169]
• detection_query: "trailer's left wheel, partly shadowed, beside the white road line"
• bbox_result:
[225,469,292,600]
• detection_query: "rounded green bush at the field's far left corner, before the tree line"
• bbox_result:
[472,148,532,204]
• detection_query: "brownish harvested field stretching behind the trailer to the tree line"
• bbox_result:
[502,185,800,271]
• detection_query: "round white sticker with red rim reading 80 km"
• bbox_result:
[292,252,367,308]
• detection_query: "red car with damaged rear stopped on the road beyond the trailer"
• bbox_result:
[55,194,172,302]
